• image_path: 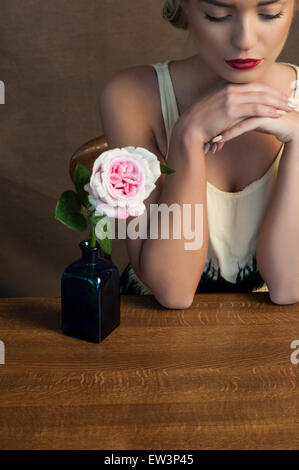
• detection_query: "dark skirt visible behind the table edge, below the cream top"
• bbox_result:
[120,257,267,295]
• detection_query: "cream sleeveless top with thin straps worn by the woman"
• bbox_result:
[152,60,299,283]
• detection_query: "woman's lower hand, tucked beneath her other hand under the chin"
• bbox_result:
[211,98,299,150]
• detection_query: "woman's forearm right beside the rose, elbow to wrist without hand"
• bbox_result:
[140,125,208,308]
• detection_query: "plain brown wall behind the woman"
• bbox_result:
[0,0,299,297]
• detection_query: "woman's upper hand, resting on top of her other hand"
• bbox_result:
[179,81,293,149]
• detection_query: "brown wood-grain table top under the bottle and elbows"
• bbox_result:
[0,292,299,450]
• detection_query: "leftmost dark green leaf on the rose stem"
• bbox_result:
[55,191,87,232]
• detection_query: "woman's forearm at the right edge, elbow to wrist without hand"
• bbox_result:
[256,136,299,304]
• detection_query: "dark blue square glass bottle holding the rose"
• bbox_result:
[61,240,120,343]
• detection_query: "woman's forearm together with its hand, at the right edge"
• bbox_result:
[211,103,299,304]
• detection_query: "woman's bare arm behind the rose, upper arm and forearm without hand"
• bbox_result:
[101,70,208,308]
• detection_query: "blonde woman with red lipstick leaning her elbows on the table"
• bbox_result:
[102,0,299,308]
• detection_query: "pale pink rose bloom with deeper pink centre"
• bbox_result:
[84,147,161,219]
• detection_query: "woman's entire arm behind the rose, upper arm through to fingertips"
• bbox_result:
[101,68,290,308]
